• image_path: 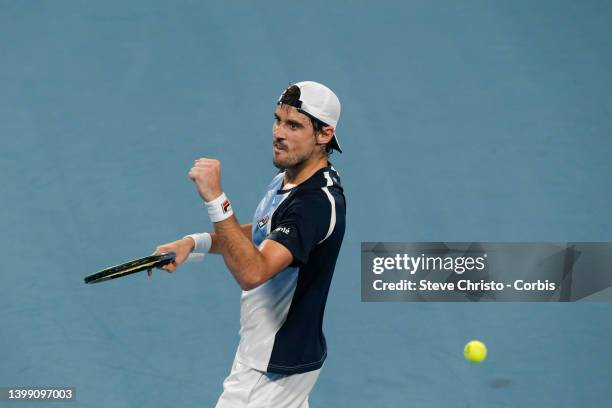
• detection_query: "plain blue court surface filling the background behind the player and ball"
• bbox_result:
[0,0,612,408]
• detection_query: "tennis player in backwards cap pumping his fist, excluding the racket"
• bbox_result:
[156,81,346,408]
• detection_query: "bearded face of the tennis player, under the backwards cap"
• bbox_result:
[272,105,316,169]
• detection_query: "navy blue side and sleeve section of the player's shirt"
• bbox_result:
[267,168,346,374]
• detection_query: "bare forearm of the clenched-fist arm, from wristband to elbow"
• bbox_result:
[211,216,265,290]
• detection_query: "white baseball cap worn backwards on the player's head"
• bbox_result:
[278,81,342,153]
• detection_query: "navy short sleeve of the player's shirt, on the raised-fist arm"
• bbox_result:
[267,190,332,265]
